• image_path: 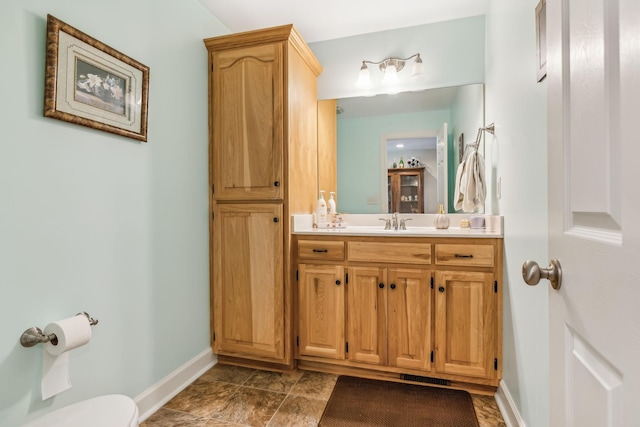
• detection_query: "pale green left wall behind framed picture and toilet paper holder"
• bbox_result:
[0,0,229,427]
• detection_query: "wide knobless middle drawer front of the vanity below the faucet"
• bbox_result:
[347,242,431,265]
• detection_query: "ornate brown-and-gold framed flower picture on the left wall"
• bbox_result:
[44,15,149,142]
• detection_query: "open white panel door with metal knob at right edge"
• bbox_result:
[547,0,640,427]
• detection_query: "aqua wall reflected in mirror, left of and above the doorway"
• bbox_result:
[338,110,450,213]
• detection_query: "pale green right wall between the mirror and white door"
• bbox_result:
[485,0,562,427]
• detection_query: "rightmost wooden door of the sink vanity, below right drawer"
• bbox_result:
[435,271,497,378]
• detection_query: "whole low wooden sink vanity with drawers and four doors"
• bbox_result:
[296,234,502,393]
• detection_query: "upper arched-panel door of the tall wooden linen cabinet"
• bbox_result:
[211,43,284,200]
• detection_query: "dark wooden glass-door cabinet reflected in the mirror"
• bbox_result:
[387,167,424,213]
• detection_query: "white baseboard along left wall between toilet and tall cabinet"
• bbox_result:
[135,348,218,423]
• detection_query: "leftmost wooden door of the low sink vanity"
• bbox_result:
[298,264,345,359]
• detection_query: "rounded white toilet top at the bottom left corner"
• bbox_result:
[22,394,138,427]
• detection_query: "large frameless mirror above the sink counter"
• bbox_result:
[336,84,484,213]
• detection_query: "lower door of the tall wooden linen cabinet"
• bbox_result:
[213,204,285,361]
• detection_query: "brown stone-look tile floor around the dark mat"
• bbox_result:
[141,365,505,427]
